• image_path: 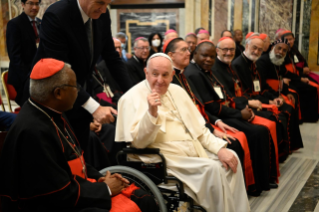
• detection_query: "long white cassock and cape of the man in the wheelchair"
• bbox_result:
[115,80,250,212]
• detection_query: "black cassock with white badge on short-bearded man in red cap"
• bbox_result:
[232,54,288,160]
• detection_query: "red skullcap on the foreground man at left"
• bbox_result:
[30,58,64,80]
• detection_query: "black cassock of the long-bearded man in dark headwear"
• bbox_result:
[256,54,303,154]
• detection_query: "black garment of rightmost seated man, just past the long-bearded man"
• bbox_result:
[284,48,318,122]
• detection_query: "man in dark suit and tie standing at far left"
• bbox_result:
[6,0,41,97]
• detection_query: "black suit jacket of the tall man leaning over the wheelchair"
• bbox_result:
[27,0,132,108]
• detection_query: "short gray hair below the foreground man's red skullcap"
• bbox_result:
[30,63,71,102]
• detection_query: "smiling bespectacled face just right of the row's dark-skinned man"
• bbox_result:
[216,39,236,64]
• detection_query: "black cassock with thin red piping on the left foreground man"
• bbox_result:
[0,101,158,212]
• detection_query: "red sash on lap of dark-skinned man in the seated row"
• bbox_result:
[251,116,280,183]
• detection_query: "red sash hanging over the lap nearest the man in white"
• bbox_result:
[212,124,255,189]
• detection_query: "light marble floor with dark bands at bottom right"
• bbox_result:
[249,123,319,212]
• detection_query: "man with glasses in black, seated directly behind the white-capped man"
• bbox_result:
[127,37,151,85]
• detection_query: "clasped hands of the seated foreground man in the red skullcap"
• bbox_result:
[98,171,130,196]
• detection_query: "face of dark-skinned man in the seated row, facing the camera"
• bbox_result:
[194,43,216,71]
